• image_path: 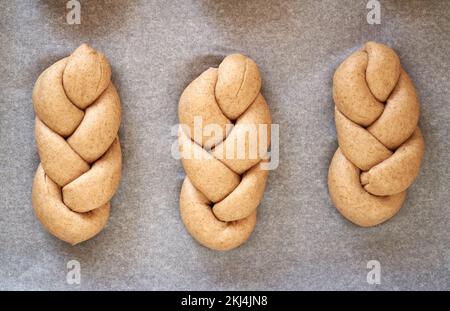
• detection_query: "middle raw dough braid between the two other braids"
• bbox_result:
[178,54,272,250]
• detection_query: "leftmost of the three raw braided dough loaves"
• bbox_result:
[32,44,122,244]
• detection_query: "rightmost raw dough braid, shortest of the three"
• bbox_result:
[328,42,424,227]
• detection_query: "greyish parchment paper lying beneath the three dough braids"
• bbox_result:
[0,0,450,290]
